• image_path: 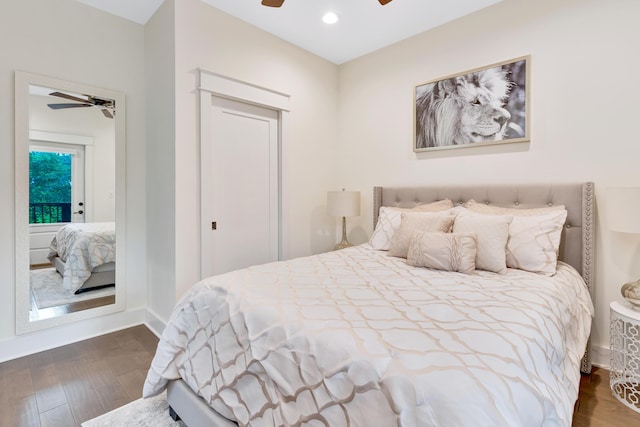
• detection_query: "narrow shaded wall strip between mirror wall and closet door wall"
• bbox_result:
[145,0,176,322]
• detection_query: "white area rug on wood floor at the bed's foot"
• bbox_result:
[82,393,184,427]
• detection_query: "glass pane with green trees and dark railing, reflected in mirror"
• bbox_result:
[29,151,72,224]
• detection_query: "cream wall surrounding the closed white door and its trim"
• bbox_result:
[150,0,341,317]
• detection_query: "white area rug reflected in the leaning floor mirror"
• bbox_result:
[30,267,115,309]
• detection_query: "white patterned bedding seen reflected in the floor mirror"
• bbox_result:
[47,222,116,291]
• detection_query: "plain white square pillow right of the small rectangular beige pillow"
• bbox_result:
[453,209,513,274]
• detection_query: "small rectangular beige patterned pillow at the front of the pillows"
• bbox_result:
[407,232,476,273]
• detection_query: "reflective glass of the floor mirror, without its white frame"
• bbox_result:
[29,85,116,320]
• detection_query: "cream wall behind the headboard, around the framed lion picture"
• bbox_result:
[334,0,640,364]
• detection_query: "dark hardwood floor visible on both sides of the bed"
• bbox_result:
[0,325,640,427]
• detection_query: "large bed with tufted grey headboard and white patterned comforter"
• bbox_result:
[143,183,593,427]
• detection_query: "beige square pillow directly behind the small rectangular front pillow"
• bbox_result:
[387,212,455,258]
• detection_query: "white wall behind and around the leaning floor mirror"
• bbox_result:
[0,0,146,360]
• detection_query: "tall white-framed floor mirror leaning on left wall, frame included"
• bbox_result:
[15,71,126,334]
